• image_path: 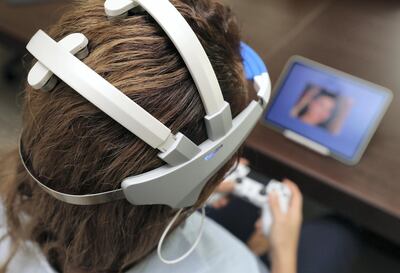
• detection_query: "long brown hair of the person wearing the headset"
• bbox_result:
[1,0,247,272]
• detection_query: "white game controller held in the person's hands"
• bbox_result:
[208,164,292,235]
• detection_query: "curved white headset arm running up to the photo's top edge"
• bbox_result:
[104,0,225,116]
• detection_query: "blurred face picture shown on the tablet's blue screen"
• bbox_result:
[290,83,351,134]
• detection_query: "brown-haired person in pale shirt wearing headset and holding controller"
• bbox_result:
[0,0,360,273]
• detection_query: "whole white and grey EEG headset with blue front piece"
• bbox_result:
[20,0,271,208]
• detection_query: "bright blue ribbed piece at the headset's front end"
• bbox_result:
[240,42,268,80]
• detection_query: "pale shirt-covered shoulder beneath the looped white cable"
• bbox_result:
[128,213,260,273]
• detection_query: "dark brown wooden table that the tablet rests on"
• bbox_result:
[0,0,400,243]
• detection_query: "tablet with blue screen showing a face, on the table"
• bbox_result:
[264,56,393,165]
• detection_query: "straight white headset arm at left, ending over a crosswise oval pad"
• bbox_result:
[26,30,174,151]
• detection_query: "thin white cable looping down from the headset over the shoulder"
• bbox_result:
[157,206,206,264]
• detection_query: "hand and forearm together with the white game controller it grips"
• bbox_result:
[211,165,303,272]
